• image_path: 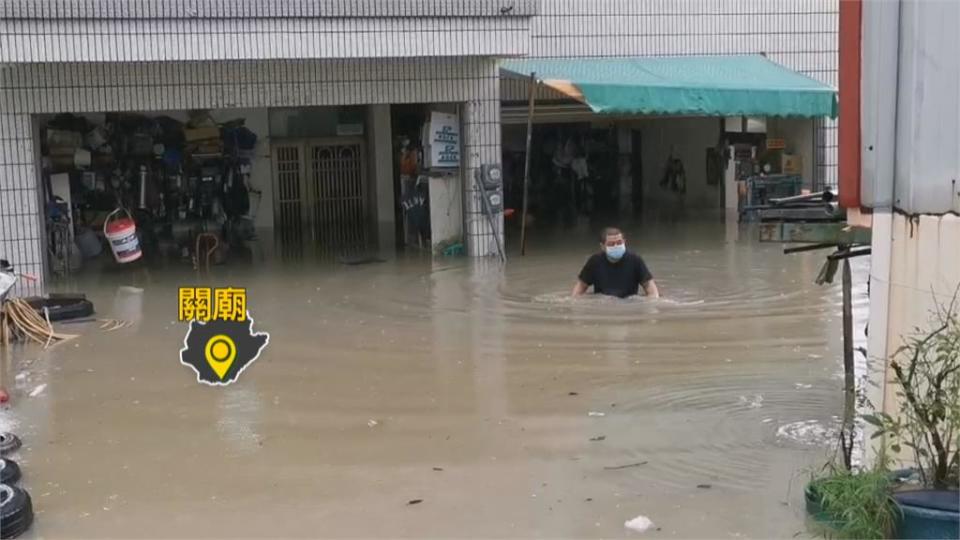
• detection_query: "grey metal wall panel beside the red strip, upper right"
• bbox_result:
[861,1,960,214]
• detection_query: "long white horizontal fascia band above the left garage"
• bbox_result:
[0,17,530,63]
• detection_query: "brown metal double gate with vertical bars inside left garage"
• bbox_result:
[273,138,368,248]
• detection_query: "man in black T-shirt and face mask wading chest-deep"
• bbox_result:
[573,227,660,298]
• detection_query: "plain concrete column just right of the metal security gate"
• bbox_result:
[367,104,397,253]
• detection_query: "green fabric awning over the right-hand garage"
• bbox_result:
[501,55,837,118]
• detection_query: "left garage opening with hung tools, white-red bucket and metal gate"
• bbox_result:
[35,107,388,276]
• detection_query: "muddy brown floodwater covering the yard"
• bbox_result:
[0,217,866,538]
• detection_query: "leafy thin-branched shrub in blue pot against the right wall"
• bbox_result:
[864,297,960,539]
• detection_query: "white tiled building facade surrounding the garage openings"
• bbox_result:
[0,0,837,292]
